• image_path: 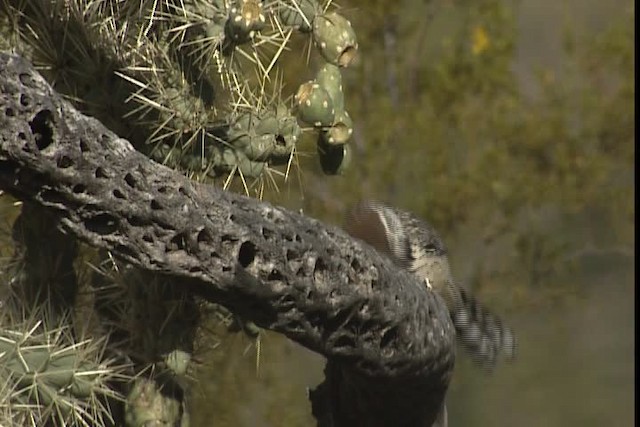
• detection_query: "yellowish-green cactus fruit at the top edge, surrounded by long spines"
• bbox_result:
[225,0,266,45]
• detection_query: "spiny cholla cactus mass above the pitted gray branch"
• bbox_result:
[0,0,357,186]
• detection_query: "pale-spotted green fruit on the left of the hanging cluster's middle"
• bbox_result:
[295,80,335,127]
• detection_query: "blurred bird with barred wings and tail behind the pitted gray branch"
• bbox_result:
[345,202,516,370]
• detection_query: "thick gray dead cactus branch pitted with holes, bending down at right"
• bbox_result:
[0,53,455,426]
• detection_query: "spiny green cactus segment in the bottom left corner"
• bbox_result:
[0,319,123,426]
